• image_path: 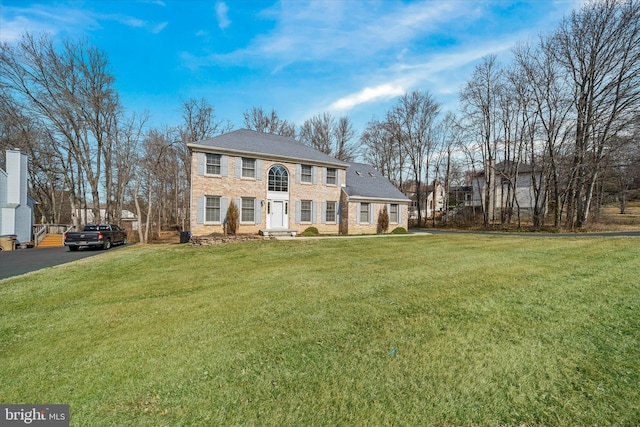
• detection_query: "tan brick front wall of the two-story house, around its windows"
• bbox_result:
[191,152,345,236]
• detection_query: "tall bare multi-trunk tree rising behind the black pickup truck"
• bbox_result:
[0,34,120,225]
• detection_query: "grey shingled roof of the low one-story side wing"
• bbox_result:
[344,163,409,203]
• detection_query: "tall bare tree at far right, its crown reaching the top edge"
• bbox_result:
[551,0,640,227]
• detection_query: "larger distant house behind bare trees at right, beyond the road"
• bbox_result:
[472,161,546,217]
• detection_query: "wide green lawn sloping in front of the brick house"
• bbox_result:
[0,235,640,426]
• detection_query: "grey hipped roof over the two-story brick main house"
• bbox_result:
[187,129,348,168]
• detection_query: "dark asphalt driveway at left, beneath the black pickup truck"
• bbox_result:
[0,246,121,280]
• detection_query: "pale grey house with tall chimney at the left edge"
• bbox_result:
[0,150,35,245]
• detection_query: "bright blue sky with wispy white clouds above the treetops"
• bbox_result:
[0,0,583,132]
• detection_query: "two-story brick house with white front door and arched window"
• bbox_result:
[188,129,408,236]
